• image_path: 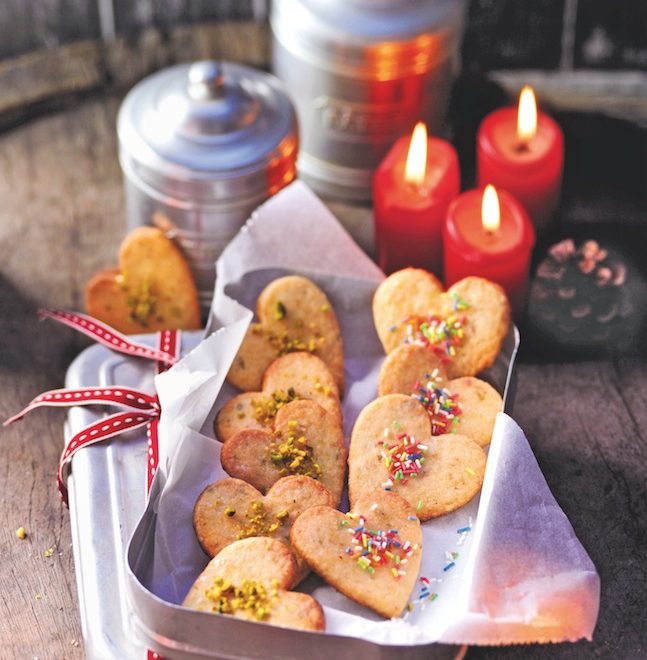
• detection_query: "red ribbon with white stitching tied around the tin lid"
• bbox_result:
[3,310,181,505]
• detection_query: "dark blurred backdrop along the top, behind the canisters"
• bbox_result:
[0,0,647,71]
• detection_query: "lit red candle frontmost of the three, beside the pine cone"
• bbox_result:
[443,186,535,314]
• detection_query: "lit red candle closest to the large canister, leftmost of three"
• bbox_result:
[373,122,460,275]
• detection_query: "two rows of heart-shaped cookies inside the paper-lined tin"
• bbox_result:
[184,269,510,630]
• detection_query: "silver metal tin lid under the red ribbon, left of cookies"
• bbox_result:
[65,332,202,660]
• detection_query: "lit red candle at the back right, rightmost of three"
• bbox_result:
[477,87,564,230]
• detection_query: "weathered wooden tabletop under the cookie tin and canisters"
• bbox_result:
[0,31,647,659]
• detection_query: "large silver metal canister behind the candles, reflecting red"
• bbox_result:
[270,0,465,200]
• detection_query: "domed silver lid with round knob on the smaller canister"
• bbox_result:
[117,60,297,201]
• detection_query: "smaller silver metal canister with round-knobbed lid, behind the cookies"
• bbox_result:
[117,61,298,306]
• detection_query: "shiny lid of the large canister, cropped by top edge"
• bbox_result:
[270,0,466,79]
